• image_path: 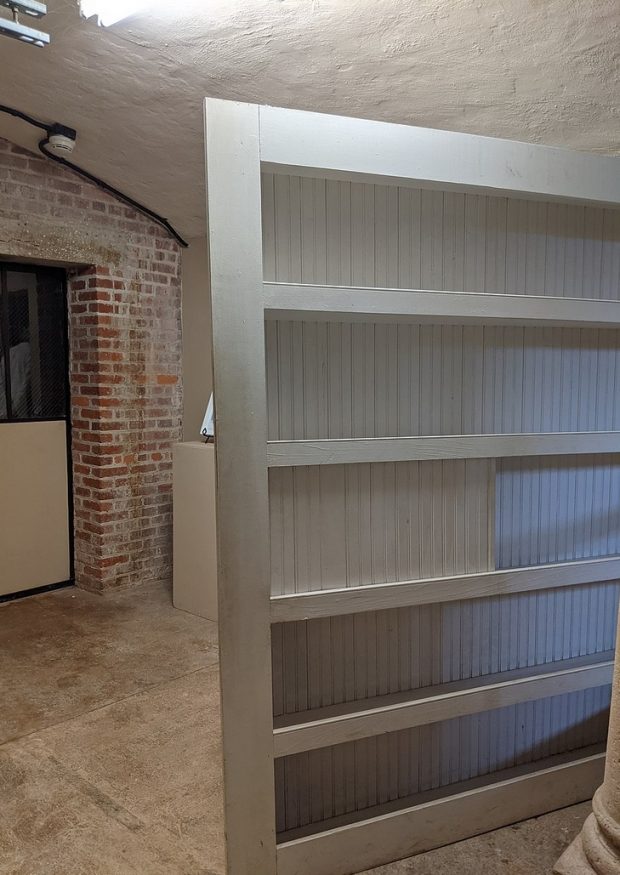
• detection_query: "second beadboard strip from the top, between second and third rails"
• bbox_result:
[266,322,620,440]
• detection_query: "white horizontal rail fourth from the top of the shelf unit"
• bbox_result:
[271,556,620,623]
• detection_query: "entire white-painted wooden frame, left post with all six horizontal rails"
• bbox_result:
[206,99,620,875]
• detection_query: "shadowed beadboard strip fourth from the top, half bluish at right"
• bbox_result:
[272,582,620,717]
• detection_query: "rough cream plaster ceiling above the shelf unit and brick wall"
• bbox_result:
[0,0,620,236]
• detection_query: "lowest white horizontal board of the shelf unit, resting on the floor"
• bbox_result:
[277,745,605,875]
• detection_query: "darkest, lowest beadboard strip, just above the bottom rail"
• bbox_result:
[276,687,610,833]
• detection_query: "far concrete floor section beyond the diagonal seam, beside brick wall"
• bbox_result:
[0,586,218,742]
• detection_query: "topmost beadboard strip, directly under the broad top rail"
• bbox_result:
[263,174,620,300]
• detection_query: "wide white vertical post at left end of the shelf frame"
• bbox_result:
[205,99,276,875]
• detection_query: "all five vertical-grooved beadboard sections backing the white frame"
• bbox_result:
[262,174,620,831]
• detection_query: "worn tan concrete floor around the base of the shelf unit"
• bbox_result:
[0,587,589,875]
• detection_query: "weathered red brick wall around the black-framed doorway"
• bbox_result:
[0,140,182,590]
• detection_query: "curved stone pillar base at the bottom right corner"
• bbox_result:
[554,616,620,875]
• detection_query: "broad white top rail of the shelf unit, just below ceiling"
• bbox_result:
[260,106,620,205]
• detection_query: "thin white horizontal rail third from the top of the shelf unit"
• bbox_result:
[267,431,620,468]
